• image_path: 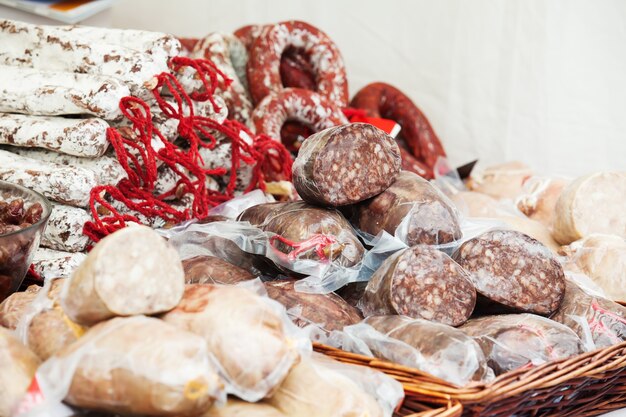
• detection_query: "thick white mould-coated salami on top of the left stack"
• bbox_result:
[0,20,173,97]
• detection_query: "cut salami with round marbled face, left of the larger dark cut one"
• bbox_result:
[360,245,476,326]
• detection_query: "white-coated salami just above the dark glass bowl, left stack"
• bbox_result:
[0,150,98,207]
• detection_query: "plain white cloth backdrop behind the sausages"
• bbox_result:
[106,0,626,175]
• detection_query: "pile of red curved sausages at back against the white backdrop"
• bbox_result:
[181,21,446,179]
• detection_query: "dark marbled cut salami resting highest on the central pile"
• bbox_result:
[293,123,401,207]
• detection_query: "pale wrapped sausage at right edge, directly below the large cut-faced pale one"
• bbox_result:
[563,234,626,301]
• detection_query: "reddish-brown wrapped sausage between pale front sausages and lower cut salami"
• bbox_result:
[264,280,361,332]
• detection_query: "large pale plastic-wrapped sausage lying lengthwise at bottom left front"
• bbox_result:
[27,316,225,417]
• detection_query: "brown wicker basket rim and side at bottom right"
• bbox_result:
[314,342,626,417]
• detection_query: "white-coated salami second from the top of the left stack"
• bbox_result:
[0,65,130,120]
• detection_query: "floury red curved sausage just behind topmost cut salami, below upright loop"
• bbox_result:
[252,88,348,140]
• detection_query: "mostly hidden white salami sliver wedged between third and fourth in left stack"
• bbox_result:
[9,148,126,185]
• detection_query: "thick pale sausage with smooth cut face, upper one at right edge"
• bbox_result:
[553,171,626,245]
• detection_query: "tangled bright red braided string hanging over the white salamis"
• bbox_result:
[83,57,292,242]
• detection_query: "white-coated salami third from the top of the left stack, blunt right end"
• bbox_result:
[0,113,109,157]
